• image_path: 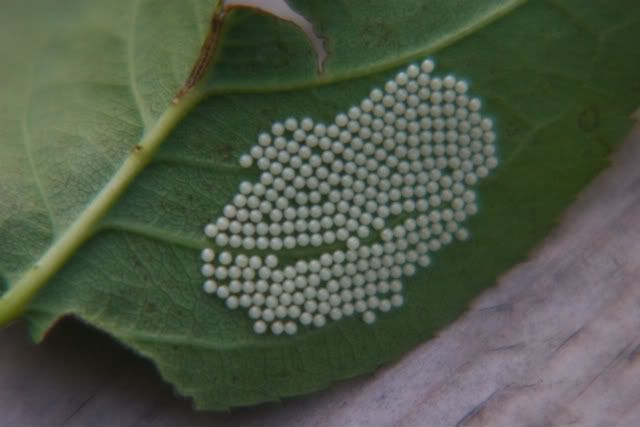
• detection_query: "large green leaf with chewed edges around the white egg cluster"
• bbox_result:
[0,0,640,409]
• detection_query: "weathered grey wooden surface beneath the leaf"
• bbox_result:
[0,125,640,427]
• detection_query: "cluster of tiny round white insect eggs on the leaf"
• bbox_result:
[201,59,498,335]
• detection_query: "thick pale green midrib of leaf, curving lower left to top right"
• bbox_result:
[0,0,528,325]
